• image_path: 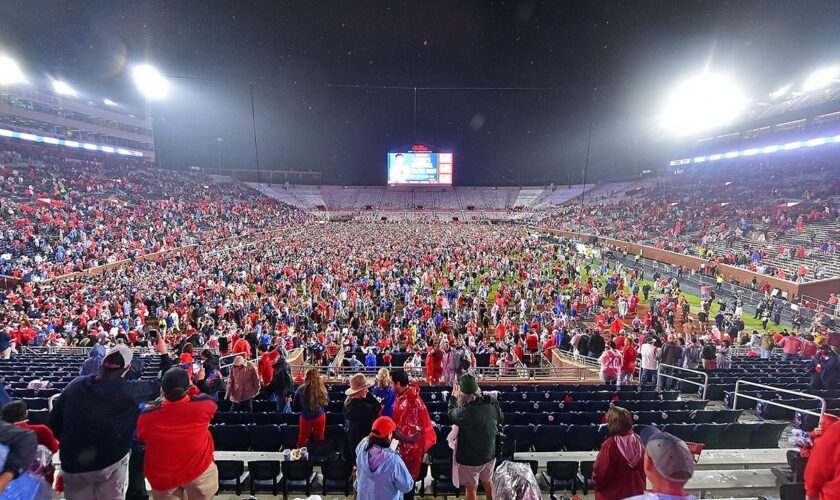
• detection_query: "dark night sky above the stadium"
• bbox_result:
[0,0,840,185]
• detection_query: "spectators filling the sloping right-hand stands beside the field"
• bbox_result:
[535,159,840,282]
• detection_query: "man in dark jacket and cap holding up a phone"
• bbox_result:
[50,342,172,500]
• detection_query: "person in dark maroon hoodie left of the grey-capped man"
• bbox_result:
[592,406,645,500]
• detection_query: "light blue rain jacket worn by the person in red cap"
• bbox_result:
[356,438,414,500]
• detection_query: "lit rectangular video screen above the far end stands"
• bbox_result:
[388,151,452,186]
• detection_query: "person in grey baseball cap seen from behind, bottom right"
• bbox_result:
[628,427,694,500]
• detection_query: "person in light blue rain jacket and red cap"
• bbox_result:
[356,417,414,500]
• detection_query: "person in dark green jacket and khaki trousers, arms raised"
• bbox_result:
[449,373,504,500]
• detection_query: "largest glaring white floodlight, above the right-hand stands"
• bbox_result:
[662,73,747,135]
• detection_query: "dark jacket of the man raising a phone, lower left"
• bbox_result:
[50,355,172,473]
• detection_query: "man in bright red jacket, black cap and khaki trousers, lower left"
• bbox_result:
[137,368,219,500]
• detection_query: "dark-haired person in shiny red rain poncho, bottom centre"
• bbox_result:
[391,369,437,498]
